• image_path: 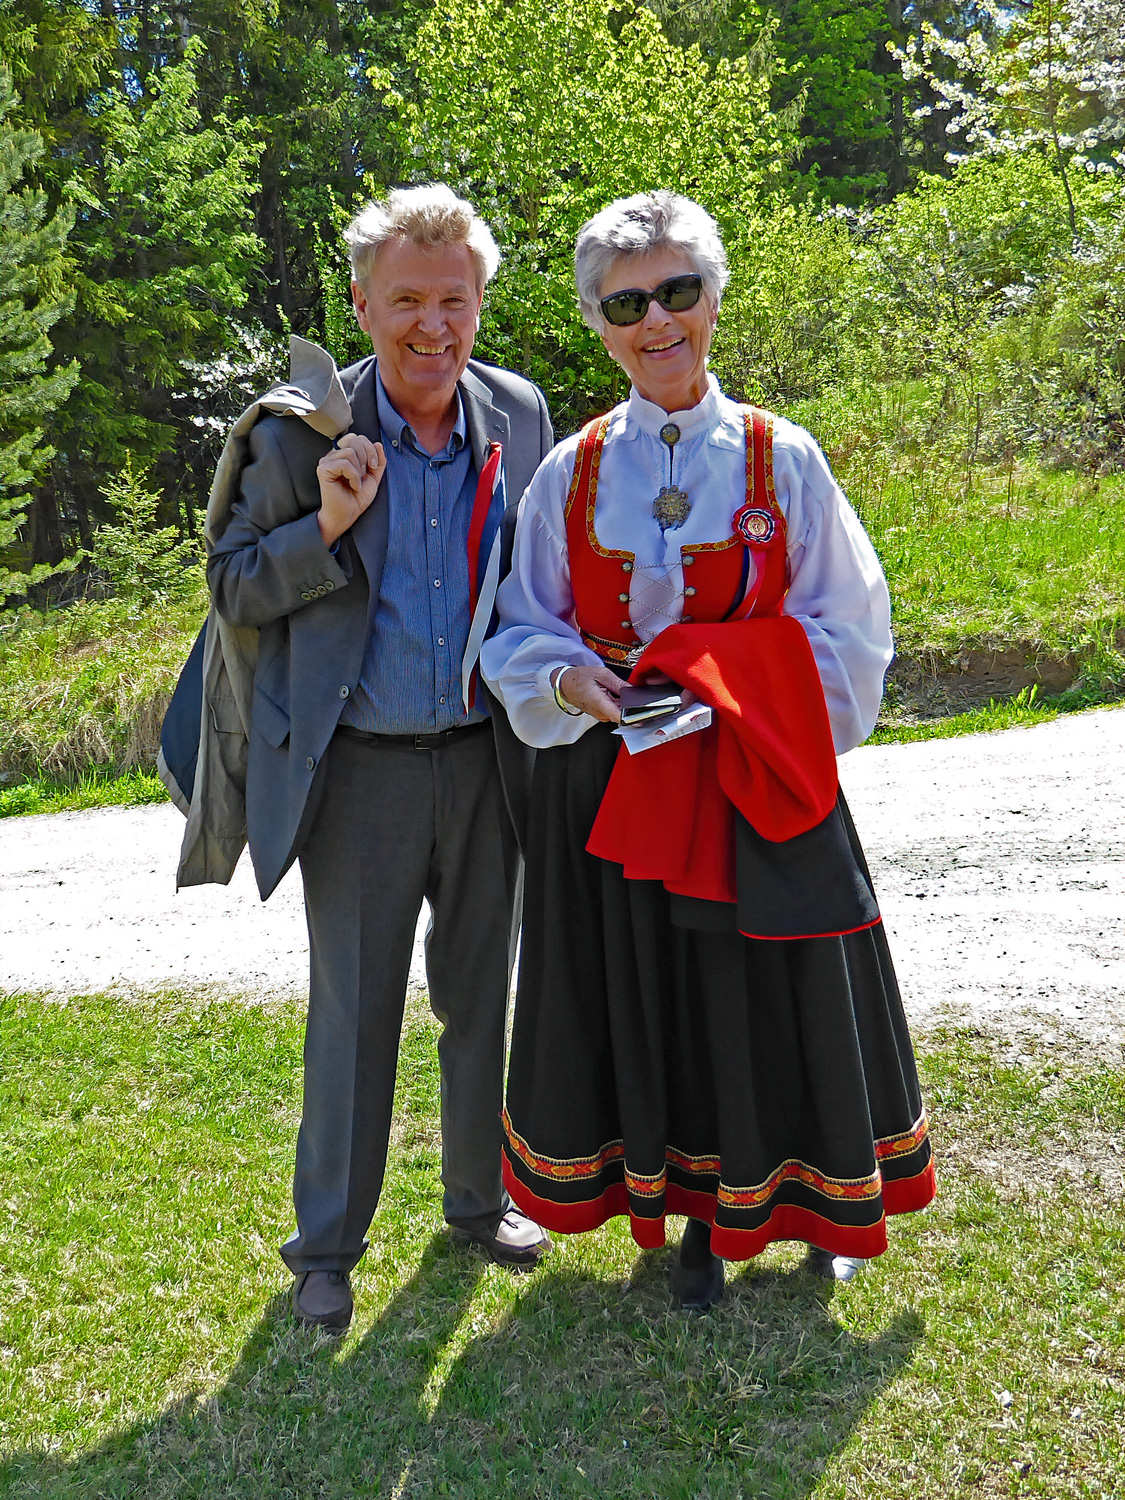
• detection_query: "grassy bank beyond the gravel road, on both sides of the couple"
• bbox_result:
[0,417,1125,816]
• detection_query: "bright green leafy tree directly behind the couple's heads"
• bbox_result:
[387,0,795,428]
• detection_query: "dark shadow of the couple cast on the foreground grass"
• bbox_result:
[0,1233,923,1500]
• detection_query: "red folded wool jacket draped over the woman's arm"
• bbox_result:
[587,615,839,902]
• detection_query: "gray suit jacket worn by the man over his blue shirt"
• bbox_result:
[207,345,554,899]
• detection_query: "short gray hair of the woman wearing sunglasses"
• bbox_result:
[575,188,731,333]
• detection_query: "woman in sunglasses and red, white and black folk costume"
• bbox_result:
[482,192,933,1310]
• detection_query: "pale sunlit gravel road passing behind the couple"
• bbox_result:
[0,708,1125,1043]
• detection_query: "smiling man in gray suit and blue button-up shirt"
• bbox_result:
[209,185,552,1329]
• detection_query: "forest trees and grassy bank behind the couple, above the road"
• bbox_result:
[0,0,1125,810]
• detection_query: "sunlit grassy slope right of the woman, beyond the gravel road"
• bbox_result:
[788,381,1125,669]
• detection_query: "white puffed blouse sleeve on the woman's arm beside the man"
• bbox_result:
[480,438,600,750]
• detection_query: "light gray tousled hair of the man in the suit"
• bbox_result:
[344,183,500,291]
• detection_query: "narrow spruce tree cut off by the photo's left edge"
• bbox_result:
[0,68,78,608]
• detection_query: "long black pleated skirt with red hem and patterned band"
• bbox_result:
[504,725,935,1260]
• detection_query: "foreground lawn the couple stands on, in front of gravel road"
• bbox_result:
[0,996,1125,1500]
